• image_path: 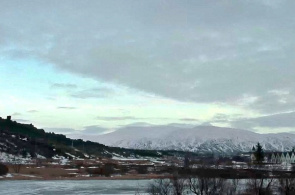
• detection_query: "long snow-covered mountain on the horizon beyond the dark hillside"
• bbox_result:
[71,125,295,153]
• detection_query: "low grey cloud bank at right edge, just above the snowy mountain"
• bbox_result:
[231,112,295,129]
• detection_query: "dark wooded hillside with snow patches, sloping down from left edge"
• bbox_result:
[0,118,194,158]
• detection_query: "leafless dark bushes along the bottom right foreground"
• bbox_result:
[146,175,295,195]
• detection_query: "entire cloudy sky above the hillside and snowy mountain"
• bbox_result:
[0,0,295,133]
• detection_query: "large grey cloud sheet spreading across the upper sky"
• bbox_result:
[0,0,295,113]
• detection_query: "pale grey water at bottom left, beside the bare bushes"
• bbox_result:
[0,180,150,195]
